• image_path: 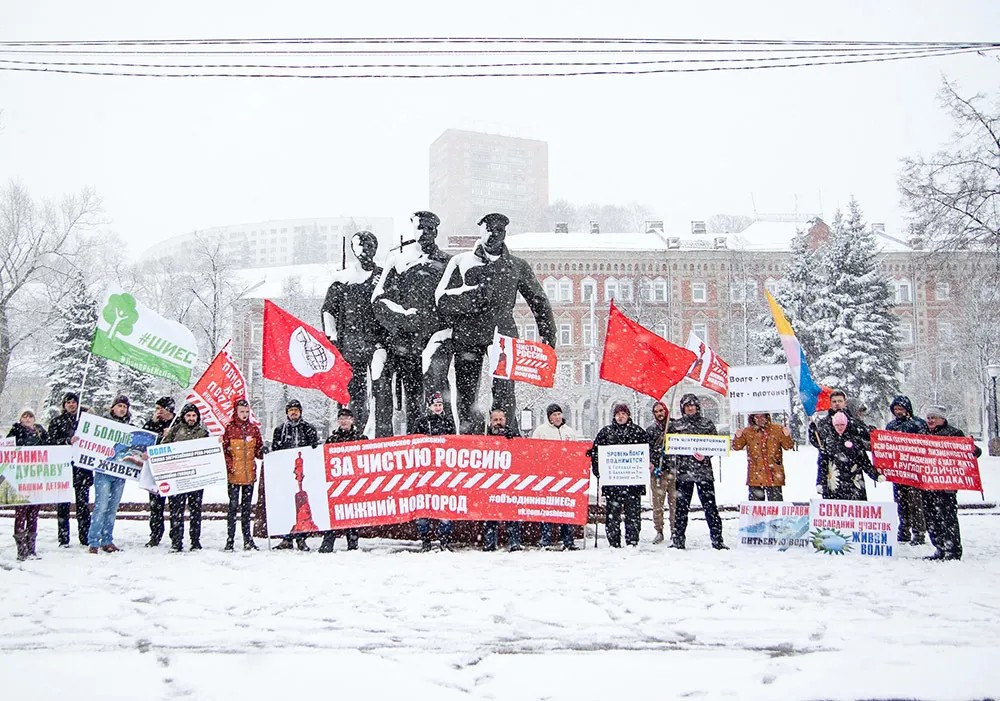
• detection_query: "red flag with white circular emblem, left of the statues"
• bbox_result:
[261,300,352,404]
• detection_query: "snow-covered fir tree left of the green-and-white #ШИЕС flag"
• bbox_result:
[48,292,115,411]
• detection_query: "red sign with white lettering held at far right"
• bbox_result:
[872,430,983,492]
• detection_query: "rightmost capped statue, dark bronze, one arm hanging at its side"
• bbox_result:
[435,212,556,433]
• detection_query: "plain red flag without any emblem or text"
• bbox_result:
[601,301,698,399]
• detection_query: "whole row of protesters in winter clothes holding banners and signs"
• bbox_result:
[0,391,981,560]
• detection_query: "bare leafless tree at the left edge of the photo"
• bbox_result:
[0,182,100,400]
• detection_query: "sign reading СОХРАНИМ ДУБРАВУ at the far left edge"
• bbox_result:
[0,445,74,505]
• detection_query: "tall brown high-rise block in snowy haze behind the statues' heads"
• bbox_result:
[430,129,549,248]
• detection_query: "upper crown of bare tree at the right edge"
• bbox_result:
[899,80,1000,267]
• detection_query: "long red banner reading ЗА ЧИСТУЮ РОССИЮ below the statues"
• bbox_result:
[264,435,590,535]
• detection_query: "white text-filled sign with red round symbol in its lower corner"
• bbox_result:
[149,438,226,497]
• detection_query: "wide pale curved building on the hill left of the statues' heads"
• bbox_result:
[144,216,399,268]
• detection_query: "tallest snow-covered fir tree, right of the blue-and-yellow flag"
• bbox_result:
[808,199,899,407]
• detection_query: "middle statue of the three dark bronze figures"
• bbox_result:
[372,211,451,431]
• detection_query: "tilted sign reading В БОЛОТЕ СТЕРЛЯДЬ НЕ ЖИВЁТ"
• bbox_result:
[73,412,156,481]
